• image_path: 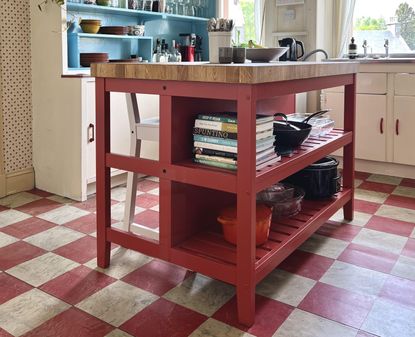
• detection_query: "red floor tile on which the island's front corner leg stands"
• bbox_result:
[212,295,294,337]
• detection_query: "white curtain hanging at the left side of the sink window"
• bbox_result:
[333,0,356,57]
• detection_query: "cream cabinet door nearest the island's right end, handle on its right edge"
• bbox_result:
[356,94,386,161]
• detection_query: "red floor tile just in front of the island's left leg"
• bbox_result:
[40,266,116,305]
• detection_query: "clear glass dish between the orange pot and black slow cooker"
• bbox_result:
[257,183,305,220]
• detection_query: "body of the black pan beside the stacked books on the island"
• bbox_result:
[274,113,312,148]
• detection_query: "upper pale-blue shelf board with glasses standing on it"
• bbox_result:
[66,2,209,23]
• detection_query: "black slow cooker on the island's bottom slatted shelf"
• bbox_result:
[286,156,341,199]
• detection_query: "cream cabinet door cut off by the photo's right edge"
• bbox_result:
[393,96,415,165]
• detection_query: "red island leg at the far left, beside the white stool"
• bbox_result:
[95,78,111,268]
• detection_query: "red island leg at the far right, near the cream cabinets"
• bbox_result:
[343,75,356,220]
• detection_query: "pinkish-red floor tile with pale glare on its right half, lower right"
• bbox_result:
[298,283,373,328]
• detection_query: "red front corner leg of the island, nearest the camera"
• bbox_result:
[236,86,256,326]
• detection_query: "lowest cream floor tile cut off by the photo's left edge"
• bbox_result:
[0,289,70,336]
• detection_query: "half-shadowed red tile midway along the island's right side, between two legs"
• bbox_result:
[278,250,334,281]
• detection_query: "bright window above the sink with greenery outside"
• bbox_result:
[353,0,415,54]
